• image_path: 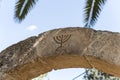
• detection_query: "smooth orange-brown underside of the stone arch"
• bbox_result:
[5,55,119,80]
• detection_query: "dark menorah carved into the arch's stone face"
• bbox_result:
[53,34,71,47]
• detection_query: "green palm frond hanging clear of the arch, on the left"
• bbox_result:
[15,0,38,22]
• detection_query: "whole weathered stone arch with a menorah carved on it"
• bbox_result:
[0,28,120,80]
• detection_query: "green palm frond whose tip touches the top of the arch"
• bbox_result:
[84,0,107,28]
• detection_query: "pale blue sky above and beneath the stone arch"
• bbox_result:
[0,0,120,80]
